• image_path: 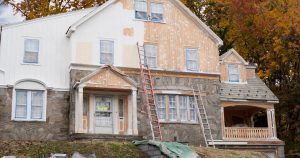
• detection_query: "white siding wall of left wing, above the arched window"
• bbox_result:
[0,9,92,89]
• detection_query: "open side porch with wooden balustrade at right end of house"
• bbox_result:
[221,105,277,141]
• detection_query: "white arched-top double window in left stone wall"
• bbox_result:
[12,80,47,121]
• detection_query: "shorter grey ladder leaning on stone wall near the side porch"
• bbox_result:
[192,85,215,148]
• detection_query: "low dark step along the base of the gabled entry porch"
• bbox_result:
[69,133,143,141]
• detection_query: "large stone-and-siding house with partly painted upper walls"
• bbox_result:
[0,0,284,157]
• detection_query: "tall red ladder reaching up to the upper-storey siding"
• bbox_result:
[137,43,162,141]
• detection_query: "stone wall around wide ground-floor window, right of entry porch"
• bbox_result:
[125,73,222,145]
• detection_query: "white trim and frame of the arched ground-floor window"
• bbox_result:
[11,80,47,122]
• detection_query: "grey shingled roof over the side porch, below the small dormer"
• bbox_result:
[220,76,279,103]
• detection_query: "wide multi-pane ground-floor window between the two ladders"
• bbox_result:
[156,94,197,123]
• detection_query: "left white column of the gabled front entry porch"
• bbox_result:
[75,86,83,133]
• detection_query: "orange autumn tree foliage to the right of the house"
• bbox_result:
[182,0,300,152]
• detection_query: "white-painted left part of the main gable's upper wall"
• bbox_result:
[71,2,144,67]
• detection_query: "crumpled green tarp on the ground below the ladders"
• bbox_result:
[133,140,201,158]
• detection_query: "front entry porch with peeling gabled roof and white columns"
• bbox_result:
[72,66,138,137]
